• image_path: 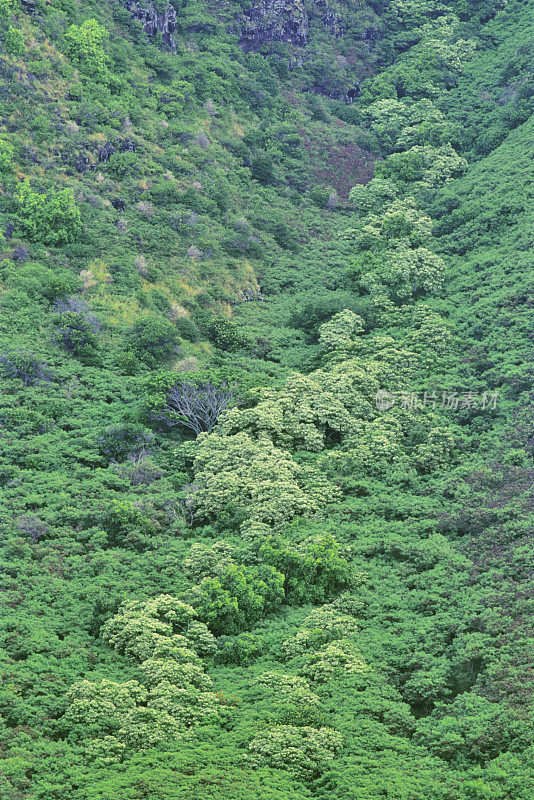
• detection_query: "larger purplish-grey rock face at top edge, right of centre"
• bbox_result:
[241,0,343,50]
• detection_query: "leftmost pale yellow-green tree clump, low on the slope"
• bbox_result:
[64,595,224,763]
